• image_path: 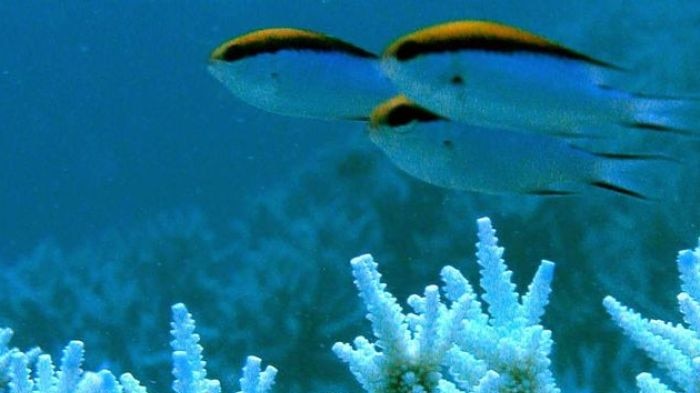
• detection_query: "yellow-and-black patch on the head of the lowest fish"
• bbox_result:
[369,95,444,130]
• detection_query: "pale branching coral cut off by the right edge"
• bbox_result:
[603,242,700,393]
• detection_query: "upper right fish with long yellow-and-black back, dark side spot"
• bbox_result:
[381,20,700,137]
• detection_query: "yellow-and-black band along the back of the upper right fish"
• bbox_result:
[384,20,617,68]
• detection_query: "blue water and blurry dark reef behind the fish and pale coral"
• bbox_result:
[0,0,700,392]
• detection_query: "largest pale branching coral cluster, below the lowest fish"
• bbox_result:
[333,218,559,393]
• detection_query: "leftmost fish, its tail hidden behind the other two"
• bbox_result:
[208,27,396,121]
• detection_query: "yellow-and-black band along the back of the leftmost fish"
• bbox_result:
[210,27,377,61]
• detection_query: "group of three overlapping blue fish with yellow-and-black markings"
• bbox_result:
[208,21,700,200]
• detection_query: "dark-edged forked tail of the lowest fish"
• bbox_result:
[589,153,682,201]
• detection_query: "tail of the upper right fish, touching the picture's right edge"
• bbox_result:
[624,94,700,138]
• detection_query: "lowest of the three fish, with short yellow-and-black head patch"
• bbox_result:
[368,95,680,201]
